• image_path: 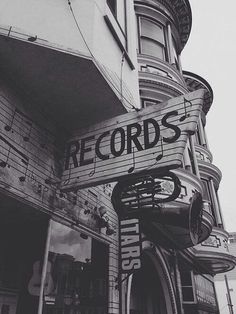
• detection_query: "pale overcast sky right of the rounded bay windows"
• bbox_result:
[181,0,236,231]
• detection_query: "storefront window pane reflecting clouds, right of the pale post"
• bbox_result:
[43,222,108,314]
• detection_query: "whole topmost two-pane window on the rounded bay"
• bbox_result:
[140,17,166,60]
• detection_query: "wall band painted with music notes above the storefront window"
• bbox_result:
[0,86,99,231]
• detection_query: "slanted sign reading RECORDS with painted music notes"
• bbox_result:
[61,89,204,190]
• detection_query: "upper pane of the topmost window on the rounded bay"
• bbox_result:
[141,18,165,45]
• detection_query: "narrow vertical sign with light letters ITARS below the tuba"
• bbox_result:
[119,218,142,274]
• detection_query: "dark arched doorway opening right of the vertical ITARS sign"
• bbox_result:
[130,255,167,314]
